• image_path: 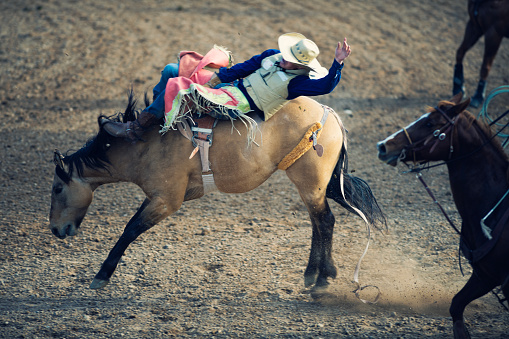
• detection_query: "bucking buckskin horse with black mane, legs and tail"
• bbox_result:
[49,93,386,289]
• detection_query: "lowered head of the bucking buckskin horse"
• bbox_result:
[49,150,94,239]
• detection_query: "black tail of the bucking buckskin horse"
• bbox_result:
[326,145,387,230]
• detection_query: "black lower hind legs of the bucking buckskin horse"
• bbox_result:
[304,201,337,287]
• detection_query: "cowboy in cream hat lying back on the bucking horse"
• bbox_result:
[104,33,351,140]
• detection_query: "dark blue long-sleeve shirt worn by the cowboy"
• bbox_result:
[217,49,344,117]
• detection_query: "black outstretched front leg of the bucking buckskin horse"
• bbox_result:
[90,198,171,289]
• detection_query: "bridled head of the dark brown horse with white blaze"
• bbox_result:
[377,94,470,166]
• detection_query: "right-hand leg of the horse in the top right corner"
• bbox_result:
[470,27,502,108]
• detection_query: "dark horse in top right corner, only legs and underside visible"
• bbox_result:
[452,0,509,107]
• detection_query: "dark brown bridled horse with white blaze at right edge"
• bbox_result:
[377,94,509,338]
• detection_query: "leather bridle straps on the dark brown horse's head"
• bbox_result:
[401,106,456,163]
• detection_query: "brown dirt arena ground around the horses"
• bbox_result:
[0,0,509,338]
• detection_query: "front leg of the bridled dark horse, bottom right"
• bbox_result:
[449,270,496,339]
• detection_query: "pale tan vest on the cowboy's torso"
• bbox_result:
[244,53,309,120]
